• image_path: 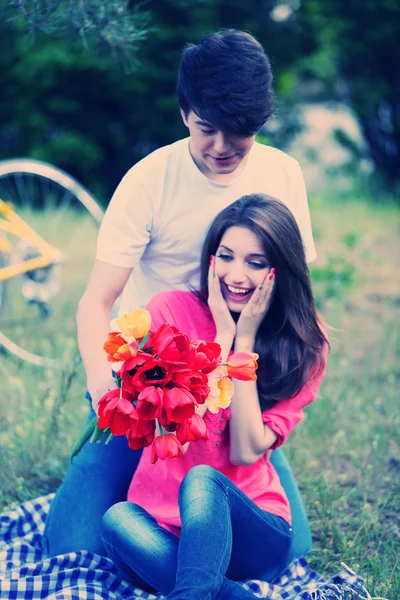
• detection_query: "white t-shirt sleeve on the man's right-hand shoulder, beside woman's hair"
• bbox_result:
[290,161,317,263]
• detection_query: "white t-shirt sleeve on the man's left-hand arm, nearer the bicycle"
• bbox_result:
[96,167,154,267]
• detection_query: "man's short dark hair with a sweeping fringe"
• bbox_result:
[177,29,273,136]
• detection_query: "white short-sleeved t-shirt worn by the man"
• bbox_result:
[97,138,315,314]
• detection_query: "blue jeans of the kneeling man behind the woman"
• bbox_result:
[42,396,311,559]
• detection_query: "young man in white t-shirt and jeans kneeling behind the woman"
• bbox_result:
[44,30,315,556]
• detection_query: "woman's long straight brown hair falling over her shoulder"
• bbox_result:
[198,194,328,410]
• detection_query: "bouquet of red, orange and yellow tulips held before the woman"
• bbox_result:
[71,309,258,463]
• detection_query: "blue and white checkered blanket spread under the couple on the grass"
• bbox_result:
[0,495,370,600]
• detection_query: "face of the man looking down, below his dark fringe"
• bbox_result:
[181,110,256,180]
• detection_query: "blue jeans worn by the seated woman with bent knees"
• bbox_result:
[101,465,291,600]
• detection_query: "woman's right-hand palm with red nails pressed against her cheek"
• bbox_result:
[235,269,276,351]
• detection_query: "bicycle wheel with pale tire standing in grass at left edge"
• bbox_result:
[0,159,103,367]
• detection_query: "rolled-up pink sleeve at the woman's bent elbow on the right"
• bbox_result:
[262,356,326,450]
